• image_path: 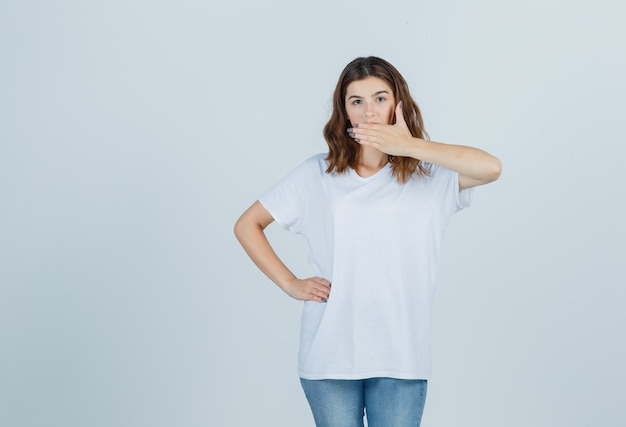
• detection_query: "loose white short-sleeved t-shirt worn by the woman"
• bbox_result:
[259,154,471,379]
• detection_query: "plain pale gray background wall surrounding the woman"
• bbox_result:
[0,0,626,427]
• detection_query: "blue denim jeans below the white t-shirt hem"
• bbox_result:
[300,378,427,427]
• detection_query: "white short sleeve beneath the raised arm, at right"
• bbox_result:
[425,163,474,215]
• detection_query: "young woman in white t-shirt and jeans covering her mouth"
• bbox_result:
[235,57,501,427]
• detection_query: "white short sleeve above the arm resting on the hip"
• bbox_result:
[259,155,312,233]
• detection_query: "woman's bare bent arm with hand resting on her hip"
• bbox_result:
[235,201,330,302]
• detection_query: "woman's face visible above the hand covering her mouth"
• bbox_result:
[345,77,396,124]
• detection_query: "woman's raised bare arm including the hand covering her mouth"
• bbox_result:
[350,104,502,189]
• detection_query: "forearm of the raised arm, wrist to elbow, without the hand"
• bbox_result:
[409,138,502,184]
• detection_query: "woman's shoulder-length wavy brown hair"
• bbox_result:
[324,56,428,183]
